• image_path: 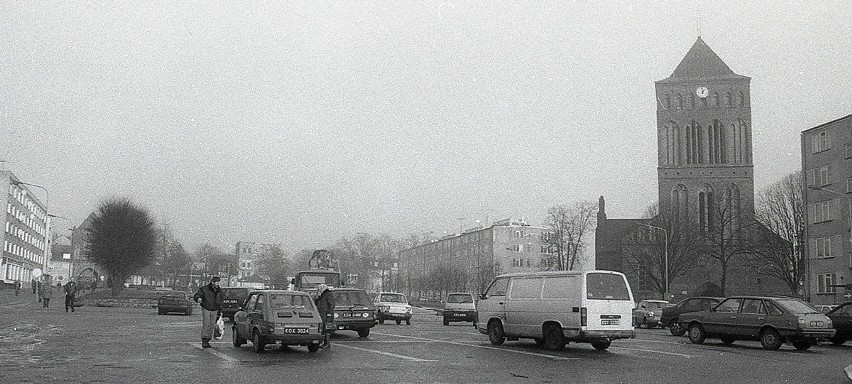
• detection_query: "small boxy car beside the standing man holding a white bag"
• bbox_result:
[231,290,323,353]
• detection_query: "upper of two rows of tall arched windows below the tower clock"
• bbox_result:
[661,119,750,165]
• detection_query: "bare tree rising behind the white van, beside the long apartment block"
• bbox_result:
[545,201,598,270]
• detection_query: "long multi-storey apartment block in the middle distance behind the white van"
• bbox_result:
[398,219,550,299]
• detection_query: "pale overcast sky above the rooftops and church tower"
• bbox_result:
[0,0,852,252]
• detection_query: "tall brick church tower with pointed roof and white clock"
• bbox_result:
[656,37,754,228]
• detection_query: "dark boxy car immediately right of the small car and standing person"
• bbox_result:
[329,288,376,337]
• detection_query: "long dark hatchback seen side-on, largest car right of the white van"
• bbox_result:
[680,296,835,350]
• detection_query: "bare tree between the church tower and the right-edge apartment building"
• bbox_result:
[754,172,806,295]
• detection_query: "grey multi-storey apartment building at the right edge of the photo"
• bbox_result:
[802,115,852,304]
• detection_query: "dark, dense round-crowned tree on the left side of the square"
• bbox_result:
[88,198,157,294]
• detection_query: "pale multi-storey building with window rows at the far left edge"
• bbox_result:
[0,170,50,286]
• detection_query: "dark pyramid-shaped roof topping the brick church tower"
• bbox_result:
[660,36,748,82]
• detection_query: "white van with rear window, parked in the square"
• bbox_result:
[474,271,636,350]
